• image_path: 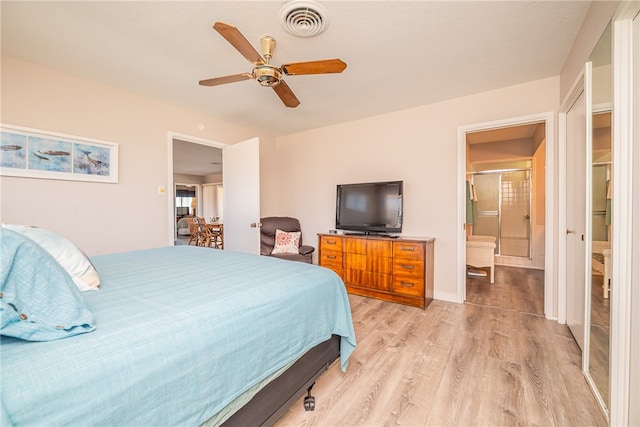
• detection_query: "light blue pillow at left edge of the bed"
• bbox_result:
[0,228,95,341]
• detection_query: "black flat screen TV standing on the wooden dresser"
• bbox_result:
[336,181,402,234]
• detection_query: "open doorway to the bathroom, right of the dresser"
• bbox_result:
[459,114,553,316]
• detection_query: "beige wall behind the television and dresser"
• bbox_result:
[277,78,559,300]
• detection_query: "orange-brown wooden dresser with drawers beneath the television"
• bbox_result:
[318,234,435,308]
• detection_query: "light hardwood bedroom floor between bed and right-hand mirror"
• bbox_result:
[276,272,606,426]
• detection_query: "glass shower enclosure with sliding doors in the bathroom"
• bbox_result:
[472,168,532,259]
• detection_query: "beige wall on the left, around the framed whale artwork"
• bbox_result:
[0,56,277,255]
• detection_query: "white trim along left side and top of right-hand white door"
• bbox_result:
[556,69,591,324]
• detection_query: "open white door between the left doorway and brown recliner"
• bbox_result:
[222,138,260,255]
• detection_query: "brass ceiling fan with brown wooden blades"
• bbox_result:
[200,22,347,108]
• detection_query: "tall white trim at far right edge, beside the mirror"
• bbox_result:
[610,6,639,425]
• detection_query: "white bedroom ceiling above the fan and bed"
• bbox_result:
[1,0,590,140]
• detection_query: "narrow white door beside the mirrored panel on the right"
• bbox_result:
[565,92,587,349]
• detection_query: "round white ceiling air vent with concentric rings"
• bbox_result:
[280,0,329,37]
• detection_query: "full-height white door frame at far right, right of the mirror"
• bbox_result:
[609,5,640,425]
